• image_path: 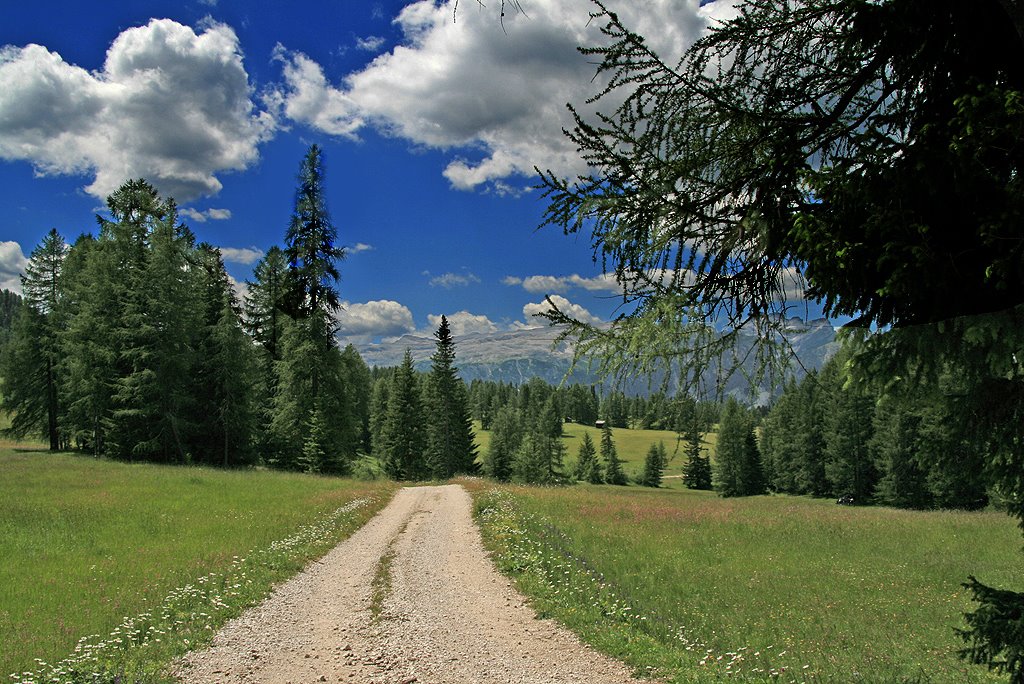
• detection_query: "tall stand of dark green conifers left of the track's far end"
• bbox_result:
[0,145,475,478]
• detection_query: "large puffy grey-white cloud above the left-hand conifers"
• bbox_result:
[0,19,274,203]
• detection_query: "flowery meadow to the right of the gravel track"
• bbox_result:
[464,480,1024,683]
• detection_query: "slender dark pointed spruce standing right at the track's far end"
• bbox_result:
[424,315,476,479]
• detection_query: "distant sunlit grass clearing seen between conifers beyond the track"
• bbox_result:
[474,422,718,488]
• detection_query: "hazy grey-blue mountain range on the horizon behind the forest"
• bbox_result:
[356,318,838,400]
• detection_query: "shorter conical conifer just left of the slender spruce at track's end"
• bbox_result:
[380,349,429,480]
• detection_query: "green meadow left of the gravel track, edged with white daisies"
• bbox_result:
[0,447,394,681]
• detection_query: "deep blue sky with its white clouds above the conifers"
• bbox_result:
[0,0,770,340]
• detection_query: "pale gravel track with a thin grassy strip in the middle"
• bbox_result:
[172,484,636,684]
